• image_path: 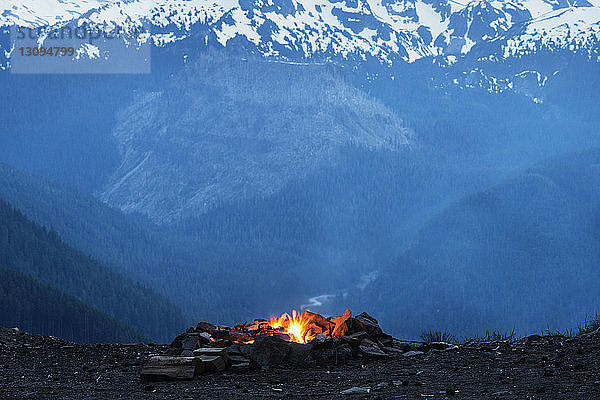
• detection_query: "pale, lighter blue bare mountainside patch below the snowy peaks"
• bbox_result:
[99,53,410,223]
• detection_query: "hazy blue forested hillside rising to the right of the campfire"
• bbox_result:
[361,149,600,335]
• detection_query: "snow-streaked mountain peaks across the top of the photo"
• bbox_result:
[0,0,600,63]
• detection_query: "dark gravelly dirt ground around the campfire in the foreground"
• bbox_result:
[0,329,600,400]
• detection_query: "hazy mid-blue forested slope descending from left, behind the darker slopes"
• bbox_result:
[0,164,322,324]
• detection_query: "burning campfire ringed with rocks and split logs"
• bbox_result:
[142,310,418,379]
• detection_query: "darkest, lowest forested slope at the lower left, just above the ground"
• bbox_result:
[0,267,149,343]
